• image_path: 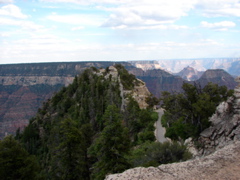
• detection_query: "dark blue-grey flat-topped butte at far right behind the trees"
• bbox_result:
[196,69,237,89]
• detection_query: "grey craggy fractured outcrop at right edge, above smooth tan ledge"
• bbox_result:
[199,77,240,154]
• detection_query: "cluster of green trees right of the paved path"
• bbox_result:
[162,83,233,140]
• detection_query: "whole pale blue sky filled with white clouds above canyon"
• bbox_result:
[0,0,240,64]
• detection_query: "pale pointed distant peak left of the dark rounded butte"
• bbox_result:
[174,66,203,81]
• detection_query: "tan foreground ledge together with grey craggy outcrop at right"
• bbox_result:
[106,77,240,180]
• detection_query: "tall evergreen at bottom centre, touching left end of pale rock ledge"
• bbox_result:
[90,105,130,179]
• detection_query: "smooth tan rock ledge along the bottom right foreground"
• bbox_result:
[106,141,240,180]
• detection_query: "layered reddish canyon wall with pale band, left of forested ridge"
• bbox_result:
[0,62,132,139]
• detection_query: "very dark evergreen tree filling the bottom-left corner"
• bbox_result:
[0,136,39,180]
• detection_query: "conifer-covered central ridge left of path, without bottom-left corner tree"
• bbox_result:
[9,65,191,180]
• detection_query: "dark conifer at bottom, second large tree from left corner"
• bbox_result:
[52,118,89,180]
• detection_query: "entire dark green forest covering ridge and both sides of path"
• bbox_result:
[0,64,232,180]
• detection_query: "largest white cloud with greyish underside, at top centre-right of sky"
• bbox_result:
[102,0,195,29]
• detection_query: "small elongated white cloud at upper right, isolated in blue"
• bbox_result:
[201,21,236,31]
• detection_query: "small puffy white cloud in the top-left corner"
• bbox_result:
[0,4,28,19]
